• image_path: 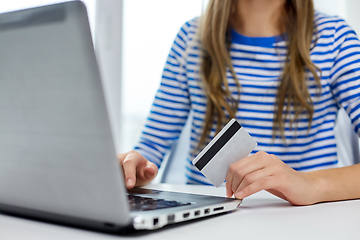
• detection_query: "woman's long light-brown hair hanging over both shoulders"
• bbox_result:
[198,0,321,149]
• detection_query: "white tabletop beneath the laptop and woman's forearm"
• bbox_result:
[0,184,360,240]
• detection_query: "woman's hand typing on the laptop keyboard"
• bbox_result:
[117,151,158,189]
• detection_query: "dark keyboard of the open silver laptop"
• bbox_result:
[128,194,191,211]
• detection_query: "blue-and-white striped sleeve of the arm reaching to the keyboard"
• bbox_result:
[135,23,190,167]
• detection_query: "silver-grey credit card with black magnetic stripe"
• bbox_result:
[192,118,257,187]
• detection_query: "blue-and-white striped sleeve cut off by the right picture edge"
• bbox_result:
[330,17,360,136]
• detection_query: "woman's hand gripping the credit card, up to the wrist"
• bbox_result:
[226,151,317,205]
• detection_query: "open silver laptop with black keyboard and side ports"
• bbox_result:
[0,1,241,231]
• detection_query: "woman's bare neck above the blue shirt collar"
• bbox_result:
[231,0,286,37]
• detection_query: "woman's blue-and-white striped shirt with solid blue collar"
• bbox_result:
[135,12,360,184]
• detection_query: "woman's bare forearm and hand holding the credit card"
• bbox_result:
[226,151,360,205]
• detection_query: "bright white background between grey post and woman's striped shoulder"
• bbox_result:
[120,0,207,152]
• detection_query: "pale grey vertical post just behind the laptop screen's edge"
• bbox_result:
[95,0,125,152]
